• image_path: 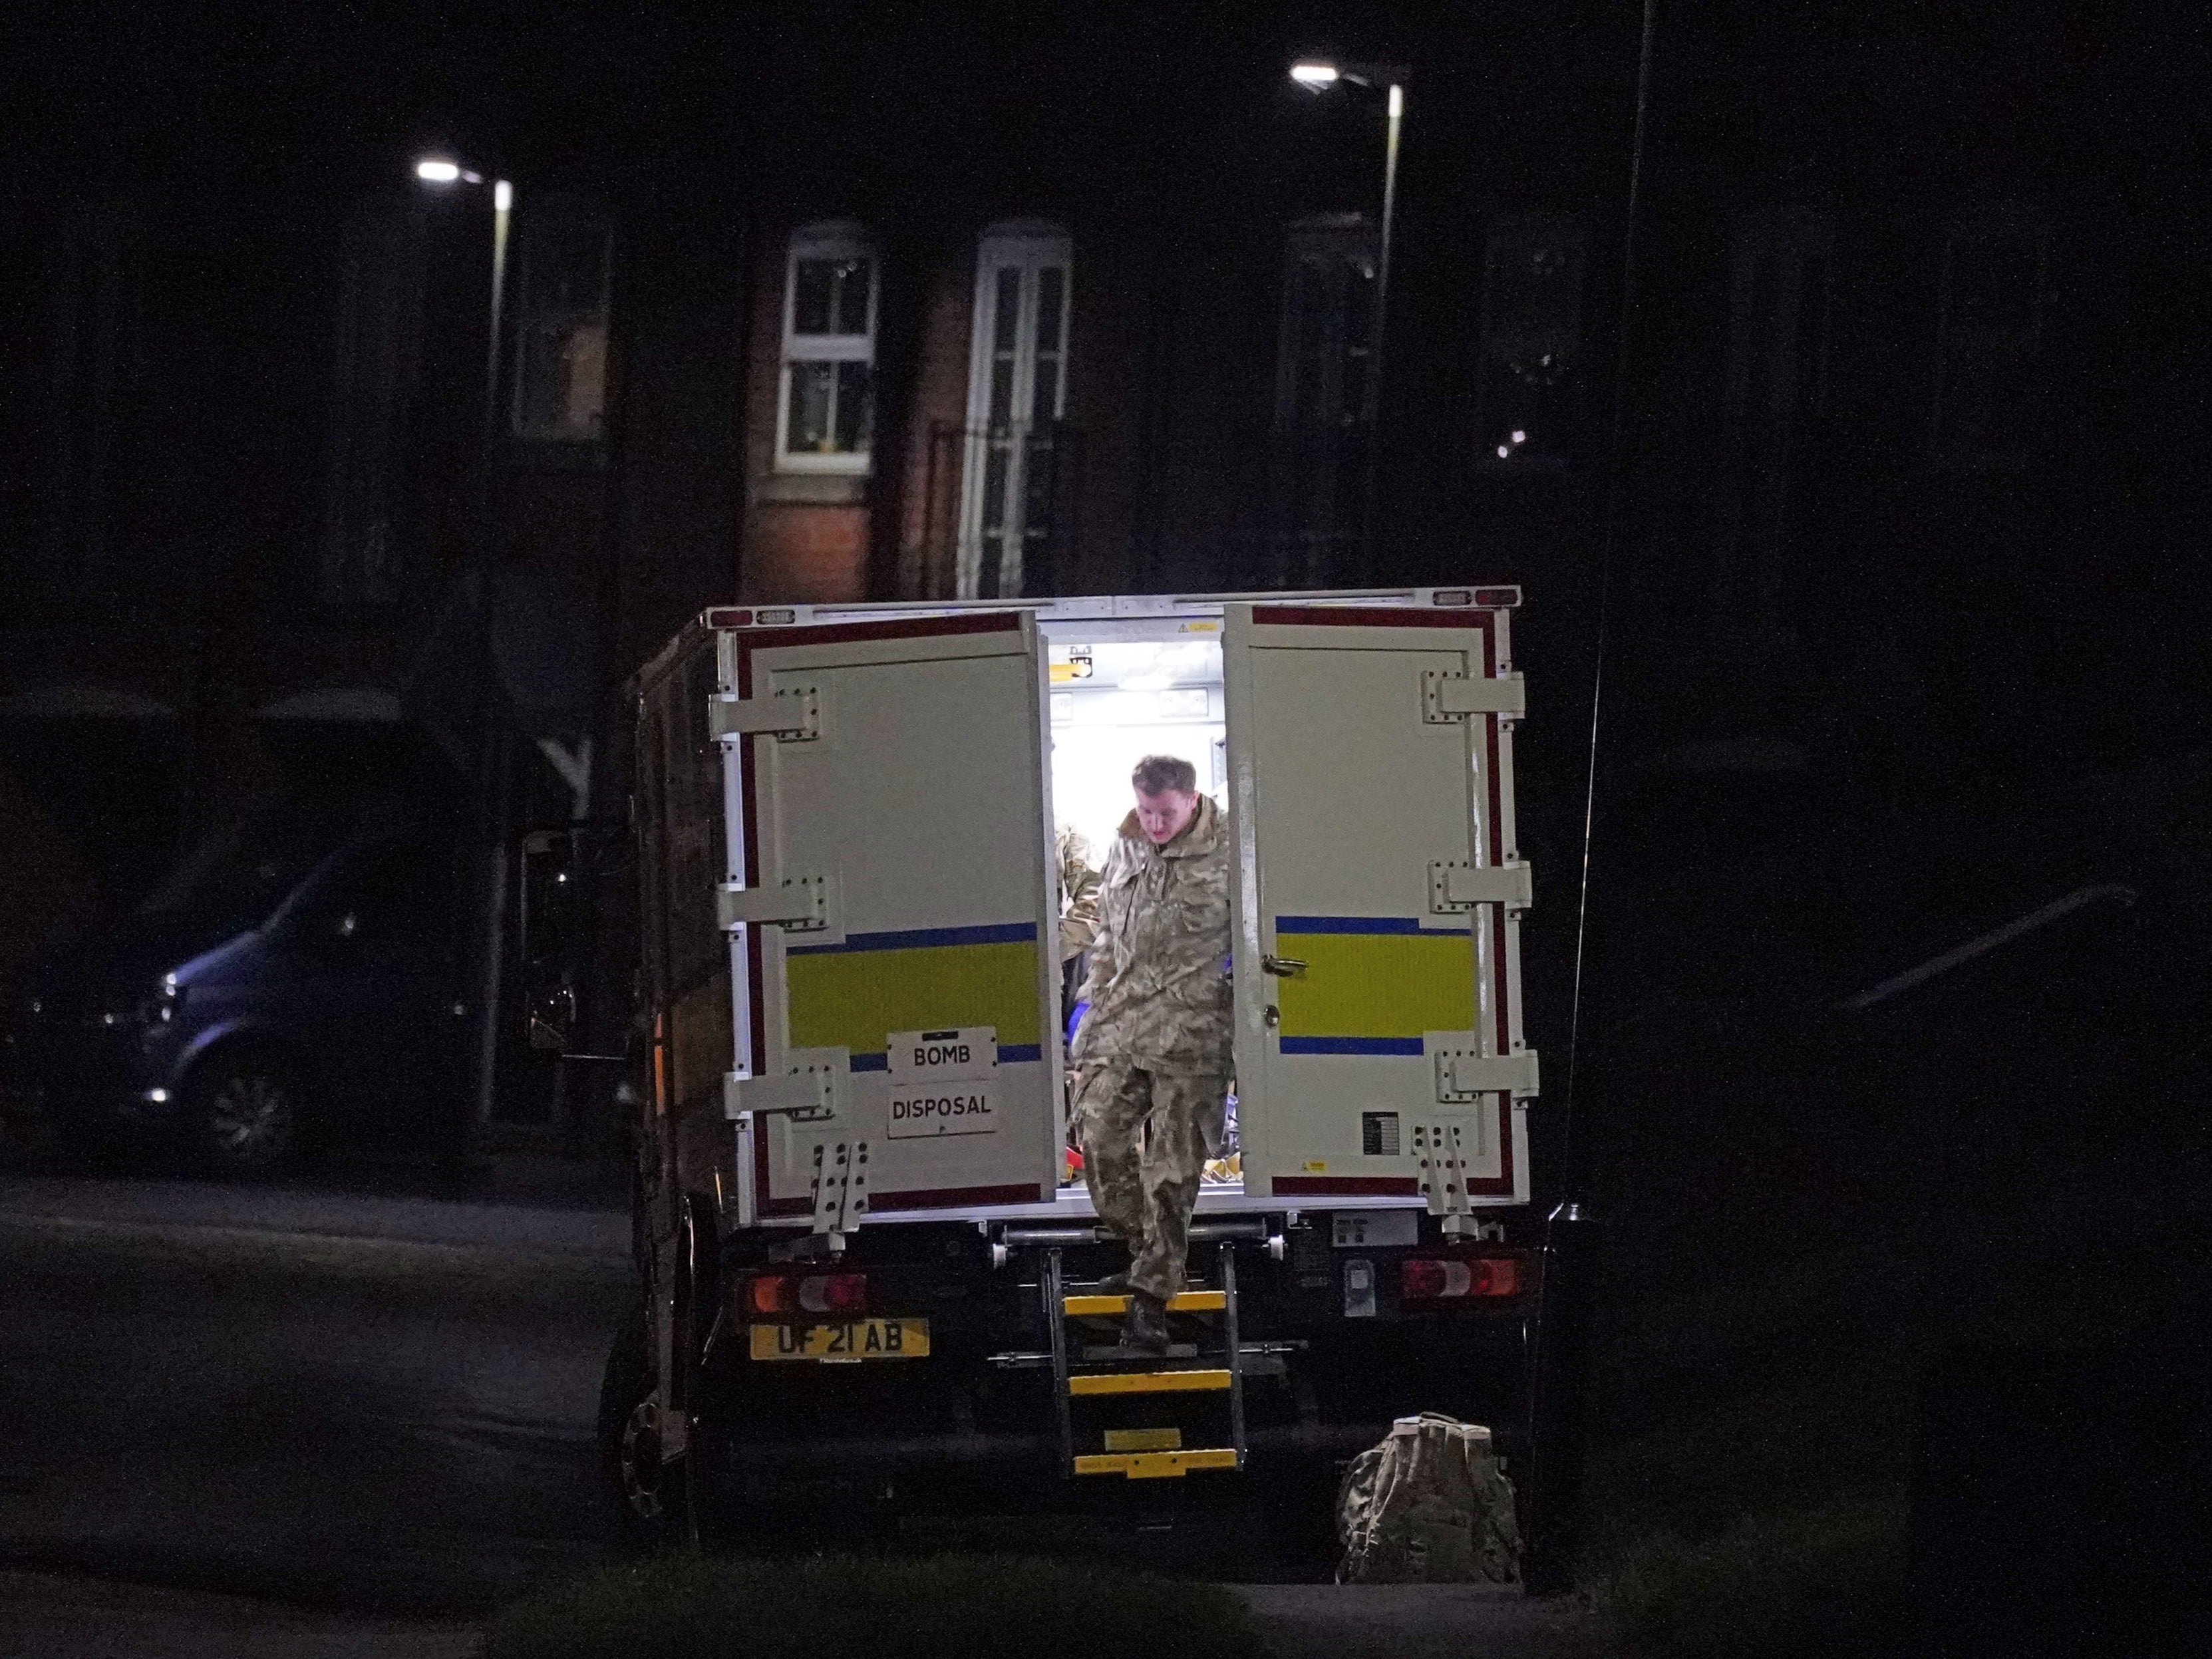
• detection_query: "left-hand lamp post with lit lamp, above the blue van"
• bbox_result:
[416,157,516,1128]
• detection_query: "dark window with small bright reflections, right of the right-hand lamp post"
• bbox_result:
[1476,217,1591,471]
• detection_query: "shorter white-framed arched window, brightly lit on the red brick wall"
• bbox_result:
[776,224,876,474]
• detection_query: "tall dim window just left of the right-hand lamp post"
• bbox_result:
[1272,212,1376,586]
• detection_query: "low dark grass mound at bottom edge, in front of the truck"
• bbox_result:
[484,1555,1265,1659]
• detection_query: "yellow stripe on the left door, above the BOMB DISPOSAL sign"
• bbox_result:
[783,940,1044,1055]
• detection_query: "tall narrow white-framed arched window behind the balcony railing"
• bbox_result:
[958,222,1073,599]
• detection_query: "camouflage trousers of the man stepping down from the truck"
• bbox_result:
[1075,1060,1227,1298]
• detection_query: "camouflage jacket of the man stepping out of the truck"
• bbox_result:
[1073,796,1232,1075]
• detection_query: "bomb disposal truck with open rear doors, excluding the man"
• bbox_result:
[599,586,1539,1535]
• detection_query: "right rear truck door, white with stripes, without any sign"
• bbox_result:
[1223,604,1535,1225]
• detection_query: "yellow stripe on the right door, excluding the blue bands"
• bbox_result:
[1277,933,1476,1038]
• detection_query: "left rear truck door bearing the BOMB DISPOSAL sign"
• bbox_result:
[714,611,1060,1232]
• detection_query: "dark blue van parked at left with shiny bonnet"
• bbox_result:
[0,810,474,1175]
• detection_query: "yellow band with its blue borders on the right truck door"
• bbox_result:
[1274,916,1476,1058]
